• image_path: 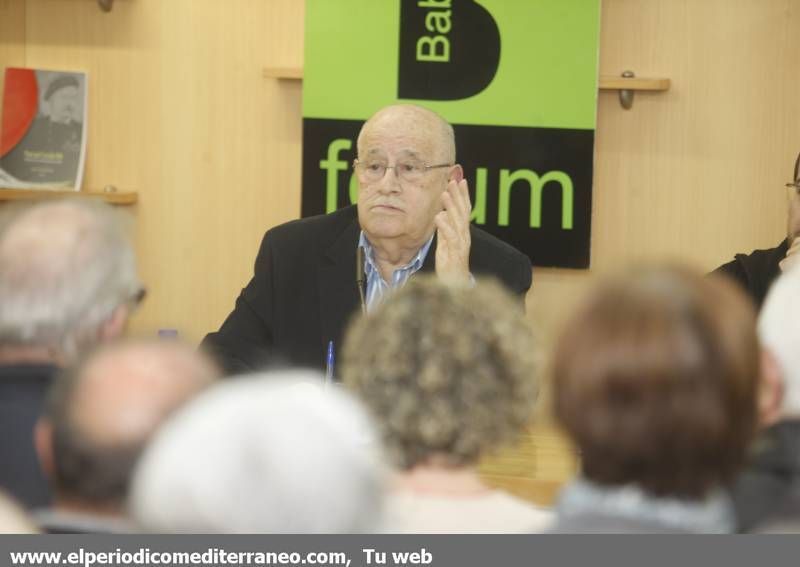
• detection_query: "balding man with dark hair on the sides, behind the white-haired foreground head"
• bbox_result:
[35,342,218,533]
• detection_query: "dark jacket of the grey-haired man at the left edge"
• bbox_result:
[0,364,56,508]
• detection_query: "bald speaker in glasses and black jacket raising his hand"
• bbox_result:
[204,105,531,372]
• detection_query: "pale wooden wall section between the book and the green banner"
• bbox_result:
[21,0,304,340]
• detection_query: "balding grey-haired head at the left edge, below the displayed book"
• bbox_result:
[0,199,143,359]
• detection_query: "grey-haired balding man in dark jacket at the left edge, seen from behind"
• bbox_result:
[0,200,143,506]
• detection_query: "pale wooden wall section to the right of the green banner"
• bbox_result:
[528,0,800,360]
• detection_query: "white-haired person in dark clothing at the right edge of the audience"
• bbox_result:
[733,266,800,533]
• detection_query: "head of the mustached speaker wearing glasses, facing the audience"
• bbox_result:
[356,104,463,250]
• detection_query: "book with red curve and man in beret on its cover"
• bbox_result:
[0,68,87,191]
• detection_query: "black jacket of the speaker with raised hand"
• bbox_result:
[202,205,531,374]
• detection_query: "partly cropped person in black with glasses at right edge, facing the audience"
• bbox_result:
[714,151,800,308]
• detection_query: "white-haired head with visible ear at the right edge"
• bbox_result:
[758,267,800,424]
